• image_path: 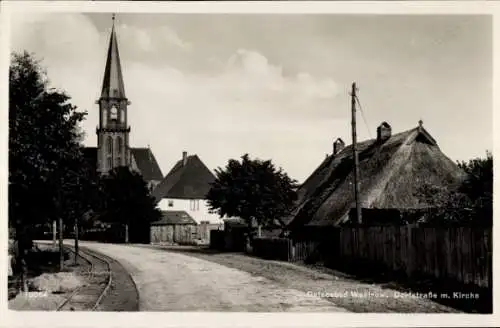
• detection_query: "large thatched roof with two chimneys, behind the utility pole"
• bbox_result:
[287,121,463,229]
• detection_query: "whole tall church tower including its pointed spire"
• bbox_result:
[96,15,131,174]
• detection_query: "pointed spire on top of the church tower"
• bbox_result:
[101,14,127,99]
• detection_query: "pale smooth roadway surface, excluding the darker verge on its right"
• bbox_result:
[81,242,346,312]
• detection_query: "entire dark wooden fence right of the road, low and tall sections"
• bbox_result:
[253,225,492,287]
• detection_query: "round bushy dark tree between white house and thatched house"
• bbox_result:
[207,154,297,238]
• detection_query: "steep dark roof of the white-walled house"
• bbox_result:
[152,155,215,201]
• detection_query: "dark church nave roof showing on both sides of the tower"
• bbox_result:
[83,147,163,181]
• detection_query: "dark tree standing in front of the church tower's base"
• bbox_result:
[103,166,162,242]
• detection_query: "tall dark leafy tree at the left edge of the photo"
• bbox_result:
[9,52,86,282]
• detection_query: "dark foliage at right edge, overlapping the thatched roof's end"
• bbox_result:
[420,152,493,225]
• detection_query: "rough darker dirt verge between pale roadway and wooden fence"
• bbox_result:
[144,245,458,313]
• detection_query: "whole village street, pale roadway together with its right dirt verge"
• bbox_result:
[72,241,456,313]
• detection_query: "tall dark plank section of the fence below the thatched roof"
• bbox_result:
[338,225,492,287]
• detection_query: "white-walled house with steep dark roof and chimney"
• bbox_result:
[152,152,223,225]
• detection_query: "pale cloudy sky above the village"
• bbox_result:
[11,13,493,182]
